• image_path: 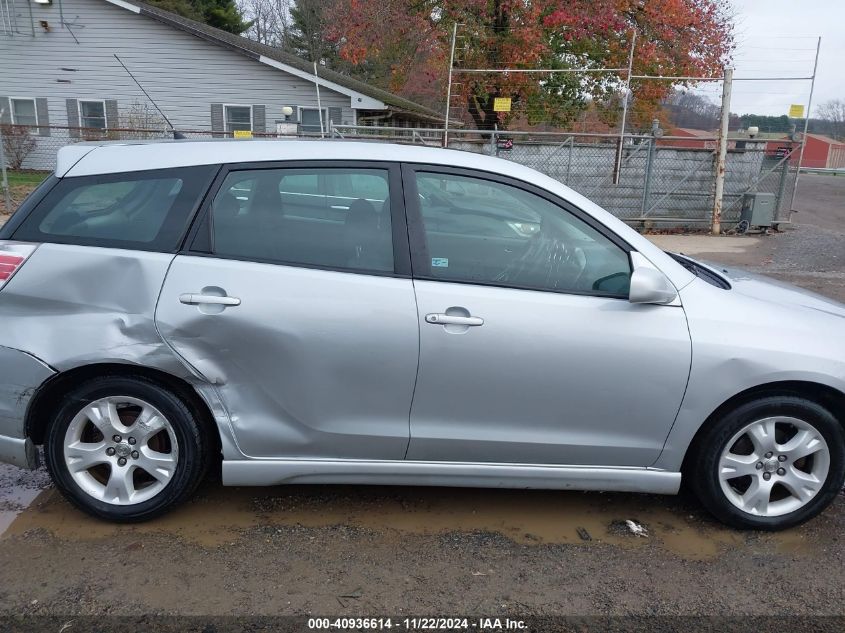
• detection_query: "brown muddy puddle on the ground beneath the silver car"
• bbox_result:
[6,484,817,560]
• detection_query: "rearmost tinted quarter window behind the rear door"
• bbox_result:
[15,165,216,252]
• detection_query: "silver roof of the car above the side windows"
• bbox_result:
[56,139,518,177]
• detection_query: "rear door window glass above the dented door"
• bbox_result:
[212,168,393,272]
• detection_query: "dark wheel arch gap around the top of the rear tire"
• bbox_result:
[24,363,221,455]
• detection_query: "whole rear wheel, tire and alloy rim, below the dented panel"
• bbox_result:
[45,376,208,522]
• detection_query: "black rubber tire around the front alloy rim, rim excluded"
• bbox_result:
[684,395,845,531]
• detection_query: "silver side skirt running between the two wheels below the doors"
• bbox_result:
[223,459,681,495]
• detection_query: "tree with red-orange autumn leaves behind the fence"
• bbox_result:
[327,0,733,129]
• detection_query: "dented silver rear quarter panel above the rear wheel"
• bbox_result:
[0,243,244,455]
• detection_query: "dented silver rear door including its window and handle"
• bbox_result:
[156,162,419,459]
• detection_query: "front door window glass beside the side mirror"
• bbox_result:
[416,172,631,296]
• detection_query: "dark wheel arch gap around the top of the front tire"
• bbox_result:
[681,380,845,473]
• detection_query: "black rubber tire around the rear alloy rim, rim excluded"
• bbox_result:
[44,375,211,523]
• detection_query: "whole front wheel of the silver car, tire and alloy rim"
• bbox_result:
[685,396,845,530]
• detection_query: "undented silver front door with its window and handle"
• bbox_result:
[403,166,691,466]
